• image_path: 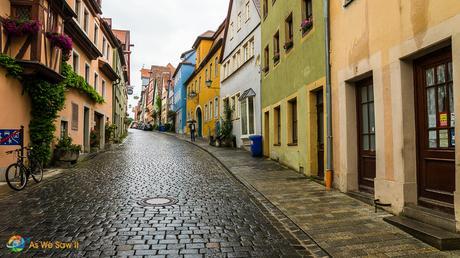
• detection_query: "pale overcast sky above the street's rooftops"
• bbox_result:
[102,0,228,115]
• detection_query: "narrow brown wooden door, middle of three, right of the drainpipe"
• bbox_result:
[356,78,375,193]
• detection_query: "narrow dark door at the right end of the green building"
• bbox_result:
[316,90,324,178]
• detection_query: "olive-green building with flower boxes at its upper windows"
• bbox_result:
[261,0,326,178]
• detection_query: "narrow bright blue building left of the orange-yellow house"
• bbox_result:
[171,50,196,134]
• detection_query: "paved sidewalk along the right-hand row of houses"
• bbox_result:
[168,135,460,257]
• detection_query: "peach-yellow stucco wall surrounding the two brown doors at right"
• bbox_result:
[331,0,460,220]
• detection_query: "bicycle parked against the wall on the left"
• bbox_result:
[5,147,43,191]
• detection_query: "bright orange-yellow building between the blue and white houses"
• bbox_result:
[185,22,225,138]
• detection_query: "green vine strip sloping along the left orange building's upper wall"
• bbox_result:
[62,63,104,104]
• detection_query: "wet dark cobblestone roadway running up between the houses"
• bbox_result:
[0,131,318,257]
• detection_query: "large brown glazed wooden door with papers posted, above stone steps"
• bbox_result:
[415,47,455,213]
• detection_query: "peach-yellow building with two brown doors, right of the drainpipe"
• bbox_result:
[330,0,460,234]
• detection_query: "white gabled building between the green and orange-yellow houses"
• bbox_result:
[220,0,261,147]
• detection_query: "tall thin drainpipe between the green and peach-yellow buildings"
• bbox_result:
[323,0,333,190]
